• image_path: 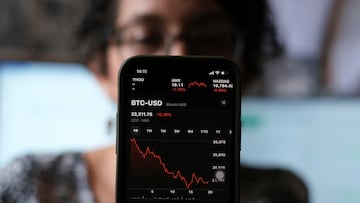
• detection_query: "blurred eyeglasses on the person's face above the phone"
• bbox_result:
[109,22,237,56]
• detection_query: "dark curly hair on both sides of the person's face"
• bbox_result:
[78,0,281,87]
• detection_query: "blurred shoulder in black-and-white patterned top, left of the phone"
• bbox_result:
[0,153,93,202]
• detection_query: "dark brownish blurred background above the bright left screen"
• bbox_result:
[0,0,88,62]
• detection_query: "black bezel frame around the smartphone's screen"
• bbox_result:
[116,55,241,203]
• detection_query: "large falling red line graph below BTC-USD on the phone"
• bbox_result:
[130,138,209,189]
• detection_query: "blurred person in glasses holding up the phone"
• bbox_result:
[0,0,307,203]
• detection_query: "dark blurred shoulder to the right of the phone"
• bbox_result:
[240,166,309,203]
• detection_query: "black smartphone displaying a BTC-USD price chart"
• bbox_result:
[116,56,241,203]
